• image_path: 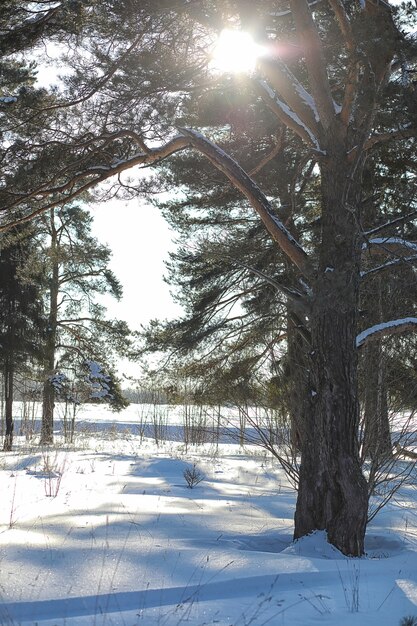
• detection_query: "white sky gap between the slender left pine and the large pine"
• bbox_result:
[92,200,181,376]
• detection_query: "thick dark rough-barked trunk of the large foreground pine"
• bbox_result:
[294,145,368,556]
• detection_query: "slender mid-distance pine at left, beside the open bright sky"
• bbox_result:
[39,205,130,444]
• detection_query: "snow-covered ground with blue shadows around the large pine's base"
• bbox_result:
[0,406,417,626]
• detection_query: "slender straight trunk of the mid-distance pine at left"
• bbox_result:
[40,209,59,445]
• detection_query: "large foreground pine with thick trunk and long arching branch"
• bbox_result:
[0,0,417,555]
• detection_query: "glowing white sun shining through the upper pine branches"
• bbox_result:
[210,29,263,73]
